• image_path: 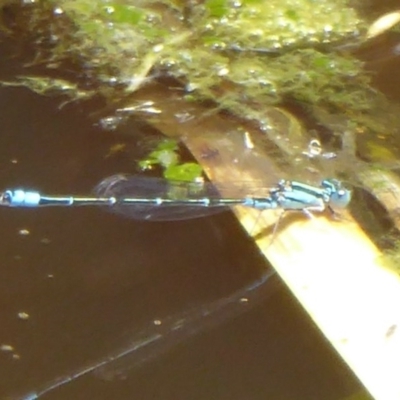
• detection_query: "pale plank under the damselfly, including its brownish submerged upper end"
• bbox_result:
[133,85,400,400]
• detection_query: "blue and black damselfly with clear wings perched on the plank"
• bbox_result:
[0,175,351,221]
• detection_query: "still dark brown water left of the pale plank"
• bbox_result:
[0,88,366,400]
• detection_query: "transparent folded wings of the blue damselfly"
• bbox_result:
[95,174,282,221]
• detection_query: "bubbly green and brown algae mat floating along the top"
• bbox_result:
[0,0,400,172]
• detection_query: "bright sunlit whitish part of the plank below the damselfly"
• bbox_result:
[236,207,400,400]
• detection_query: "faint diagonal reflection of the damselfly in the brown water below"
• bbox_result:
[14,270,279,400]
